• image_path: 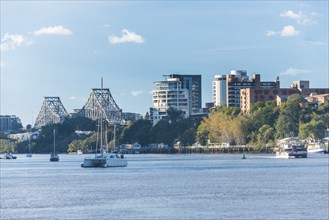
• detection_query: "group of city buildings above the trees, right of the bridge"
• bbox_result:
[150,70,329,124]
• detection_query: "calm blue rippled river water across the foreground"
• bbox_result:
[0,154,329,220]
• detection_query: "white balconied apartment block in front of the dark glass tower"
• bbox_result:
[150,78,190,124]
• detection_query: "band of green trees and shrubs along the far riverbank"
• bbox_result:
[0,94,329,153]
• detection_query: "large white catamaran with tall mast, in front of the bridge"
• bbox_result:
[81,78,127,167]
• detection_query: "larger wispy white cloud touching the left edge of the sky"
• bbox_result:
[0,33,32,51]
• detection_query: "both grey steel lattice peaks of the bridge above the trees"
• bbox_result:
[34,89,124,128]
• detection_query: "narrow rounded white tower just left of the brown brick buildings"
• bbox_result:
[212,75,226,106]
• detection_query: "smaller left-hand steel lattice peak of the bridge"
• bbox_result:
[34,97,68,128]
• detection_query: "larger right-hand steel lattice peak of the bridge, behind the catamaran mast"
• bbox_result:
[79,89,124,124]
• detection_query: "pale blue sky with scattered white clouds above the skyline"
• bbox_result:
[0,0,329,126]
